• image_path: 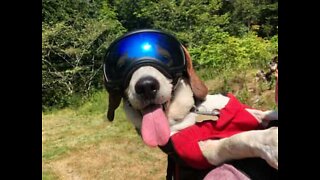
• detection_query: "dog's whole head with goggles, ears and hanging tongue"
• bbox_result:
[104,30,208,146]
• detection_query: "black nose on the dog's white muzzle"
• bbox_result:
[134,76,160,99]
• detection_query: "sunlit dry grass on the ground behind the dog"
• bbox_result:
[42,70,275,180]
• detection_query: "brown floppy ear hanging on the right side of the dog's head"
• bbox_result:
[182,46,208,100]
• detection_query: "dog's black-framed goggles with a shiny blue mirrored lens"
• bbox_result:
[104,29,186,89]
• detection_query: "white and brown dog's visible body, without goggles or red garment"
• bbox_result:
[104,29,278,179]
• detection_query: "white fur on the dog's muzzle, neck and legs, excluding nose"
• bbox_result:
[123,66,278,169]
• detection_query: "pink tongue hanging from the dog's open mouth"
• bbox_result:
[141,105,170,147]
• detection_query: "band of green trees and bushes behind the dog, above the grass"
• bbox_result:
[42,0,278,110]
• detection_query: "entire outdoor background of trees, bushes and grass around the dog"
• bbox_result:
[42,0,278,179]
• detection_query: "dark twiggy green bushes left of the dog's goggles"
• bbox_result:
[42,1,125,109]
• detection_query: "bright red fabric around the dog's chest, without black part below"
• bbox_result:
[171,94,259,169]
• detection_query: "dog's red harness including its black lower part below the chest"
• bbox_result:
[159,93,260,180]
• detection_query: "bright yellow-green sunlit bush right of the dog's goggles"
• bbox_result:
[189,33,277,76]
